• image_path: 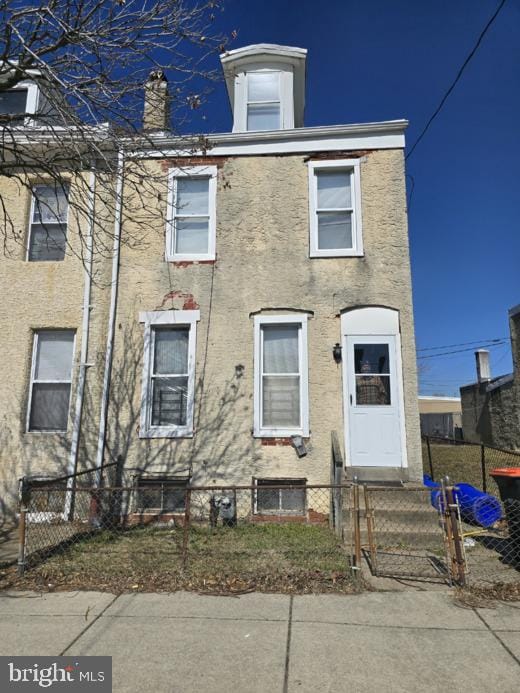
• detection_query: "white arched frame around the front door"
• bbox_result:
[341,306,408,469]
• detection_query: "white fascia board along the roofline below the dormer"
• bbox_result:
[128,120,408,158]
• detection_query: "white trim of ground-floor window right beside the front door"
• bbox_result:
[253,314,309,438]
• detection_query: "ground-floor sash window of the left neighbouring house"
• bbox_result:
[28,330,74,431]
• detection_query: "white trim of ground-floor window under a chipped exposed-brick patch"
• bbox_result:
[139,310,200,438]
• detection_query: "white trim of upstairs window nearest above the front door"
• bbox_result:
[308,159,364,257]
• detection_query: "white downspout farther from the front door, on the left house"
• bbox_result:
[64,165,96,520]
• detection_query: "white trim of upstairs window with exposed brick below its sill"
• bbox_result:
[166,166,217,262]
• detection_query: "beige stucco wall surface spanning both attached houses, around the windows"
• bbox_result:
[0,150,421,516]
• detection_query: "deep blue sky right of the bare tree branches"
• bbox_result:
[193,0,520,395]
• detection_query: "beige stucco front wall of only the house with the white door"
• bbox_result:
[109,150,421,484]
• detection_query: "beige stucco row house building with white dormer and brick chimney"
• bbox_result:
[0,44,421,520]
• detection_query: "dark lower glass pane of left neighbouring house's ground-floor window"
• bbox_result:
[29,383,70,431]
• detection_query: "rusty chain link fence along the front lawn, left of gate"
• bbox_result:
[19,480,356,592]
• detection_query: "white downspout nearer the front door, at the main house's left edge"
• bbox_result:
[95,151,124,486]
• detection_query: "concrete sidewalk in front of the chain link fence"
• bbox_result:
[0,591,520,693]
